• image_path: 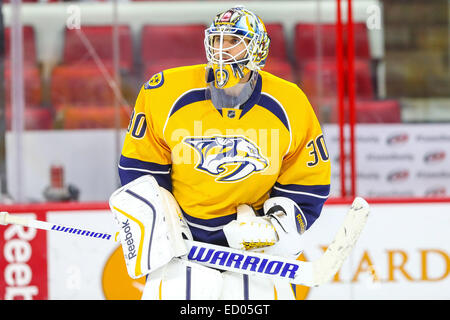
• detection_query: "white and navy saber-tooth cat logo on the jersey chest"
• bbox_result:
[183,136,269,182]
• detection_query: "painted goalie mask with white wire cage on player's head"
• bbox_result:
[204,7,270,89]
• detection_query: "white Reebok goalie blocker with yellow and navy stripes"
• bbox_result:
[109,175,192,279]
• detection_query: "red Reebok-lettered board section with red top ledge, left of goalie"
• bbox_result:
[0,202,108,300]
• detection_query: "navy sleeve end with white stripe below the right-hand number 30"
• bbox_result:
[270,183,330,230]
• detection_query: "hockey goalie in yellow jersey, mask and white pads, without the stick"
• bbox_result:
[110,7,330,299]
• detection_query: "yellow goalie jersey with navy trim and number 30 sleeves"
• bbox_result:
[119,65,330,245]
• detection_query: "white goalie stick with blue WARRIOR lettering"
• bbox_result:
[0,197,370,287]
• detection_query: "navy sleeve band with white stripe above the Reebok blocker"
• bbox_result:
[119,155,172,191]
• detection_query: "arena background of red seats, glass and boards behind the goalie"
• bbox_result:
[0,0,450,300]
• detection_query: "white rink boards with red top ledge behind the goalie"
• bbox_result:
[0,199,450,300]
